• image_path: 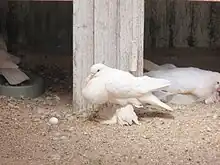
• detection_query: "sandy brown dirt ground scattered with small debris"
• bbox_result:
[0,92,220,165]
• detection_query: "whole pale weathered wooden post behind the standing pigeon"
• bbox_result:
[73,0,144,110]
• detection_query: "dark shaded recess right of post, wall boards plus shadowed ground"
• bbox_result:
[144,0,220,71]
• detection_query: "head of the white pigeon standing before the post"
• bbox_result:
[87,63,108,82]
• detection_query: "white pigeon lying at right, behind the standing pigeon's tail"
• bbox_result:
[144,60,220,104]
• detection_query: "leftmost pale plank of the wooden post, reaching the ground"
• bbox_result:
[73,0,94,110]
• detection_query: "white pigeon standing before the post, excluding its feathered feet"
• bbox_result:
[82,63,173,111]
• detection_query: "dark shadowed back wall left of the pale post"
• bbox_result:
[7,1,72,54]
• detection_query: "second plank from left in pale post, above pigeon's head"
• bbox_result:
[94,0,117,67]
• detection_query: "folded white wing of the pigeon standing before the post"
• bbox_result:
[105,76,170,98]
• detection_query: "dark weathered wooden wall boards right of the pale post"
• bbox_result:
[145,0,220,48]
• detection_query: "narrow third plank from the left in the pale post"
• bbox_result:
[118,0,133,71]
